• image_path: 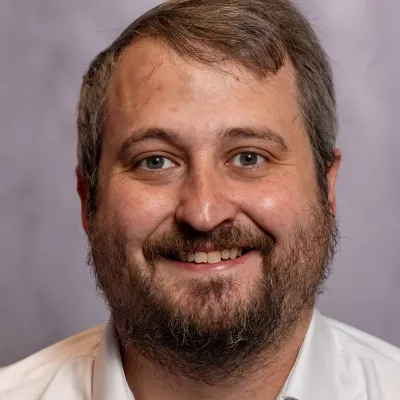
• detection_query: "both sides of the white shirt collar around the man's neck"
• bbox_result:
[93,309,338,400]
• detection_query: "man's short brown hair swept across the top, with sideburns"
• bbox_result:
[77,0,337,215]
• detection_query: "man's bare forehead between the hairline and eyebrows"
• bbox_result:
[104,39,303,147]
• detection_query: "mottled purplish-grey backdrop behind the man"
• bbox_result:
[0,0,400,365]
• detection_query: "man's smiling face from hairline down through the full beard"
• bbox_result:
[83,40,336,381]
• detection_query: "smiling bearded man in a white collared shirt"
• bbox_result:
[0,0,400,400]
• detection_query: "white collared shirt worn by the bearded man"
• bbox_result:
[0,310,400,400]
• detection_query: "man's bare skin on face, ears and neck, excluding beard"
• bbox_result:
[78,40,340,400]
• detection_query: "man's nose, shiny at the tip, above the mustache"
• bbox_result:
[176,169,237,232]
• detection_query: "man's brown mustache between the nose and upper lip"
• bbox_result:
[142,225,275,262]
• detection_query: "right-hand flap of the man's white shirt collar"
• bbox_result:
[278,309,339,400]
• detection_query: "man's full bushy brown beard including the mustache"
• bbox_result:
[87,195,338,385]
